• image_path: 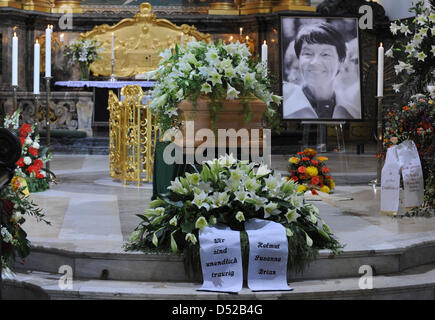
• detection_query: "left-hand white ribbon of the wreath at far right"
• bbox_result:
[381,146,400,215]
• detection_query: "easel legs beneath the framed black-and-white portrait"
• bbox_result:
[301,121,346,152]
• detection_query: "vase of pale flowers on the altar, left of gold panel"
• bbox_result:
[64,39,103,80]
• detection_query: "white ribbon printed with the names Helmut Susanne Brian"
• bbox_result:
[245,219,293,291]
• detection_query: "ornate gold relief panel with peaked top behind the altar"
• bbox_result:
[81,3,211,77]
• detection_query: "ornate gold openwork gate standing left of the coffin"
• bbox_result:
[108,85,158,186]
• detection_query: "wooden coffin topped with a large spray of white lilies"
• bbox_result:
[149,41,282,145]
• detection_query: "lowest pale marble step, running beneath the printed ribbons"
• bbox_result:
[3,264,435,303]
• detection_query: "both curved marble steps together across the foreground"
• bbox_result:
[3,239,435,300]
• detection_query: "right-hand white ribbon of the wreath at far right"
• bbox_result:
[397,140,424,208]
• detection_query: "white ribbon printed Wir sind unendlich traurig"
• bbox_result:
[198,225,243,292]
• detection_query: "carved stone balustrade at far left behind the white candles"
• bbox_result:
[0,91,94,136]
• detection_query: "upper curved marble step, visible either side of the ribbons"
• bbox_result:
[11,236,435,282]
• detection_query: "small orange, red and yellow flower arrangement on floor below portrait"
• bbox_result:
[288,148,335,195]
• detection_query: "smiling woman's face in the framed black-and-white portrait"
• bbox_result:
[299,42,340,86]
